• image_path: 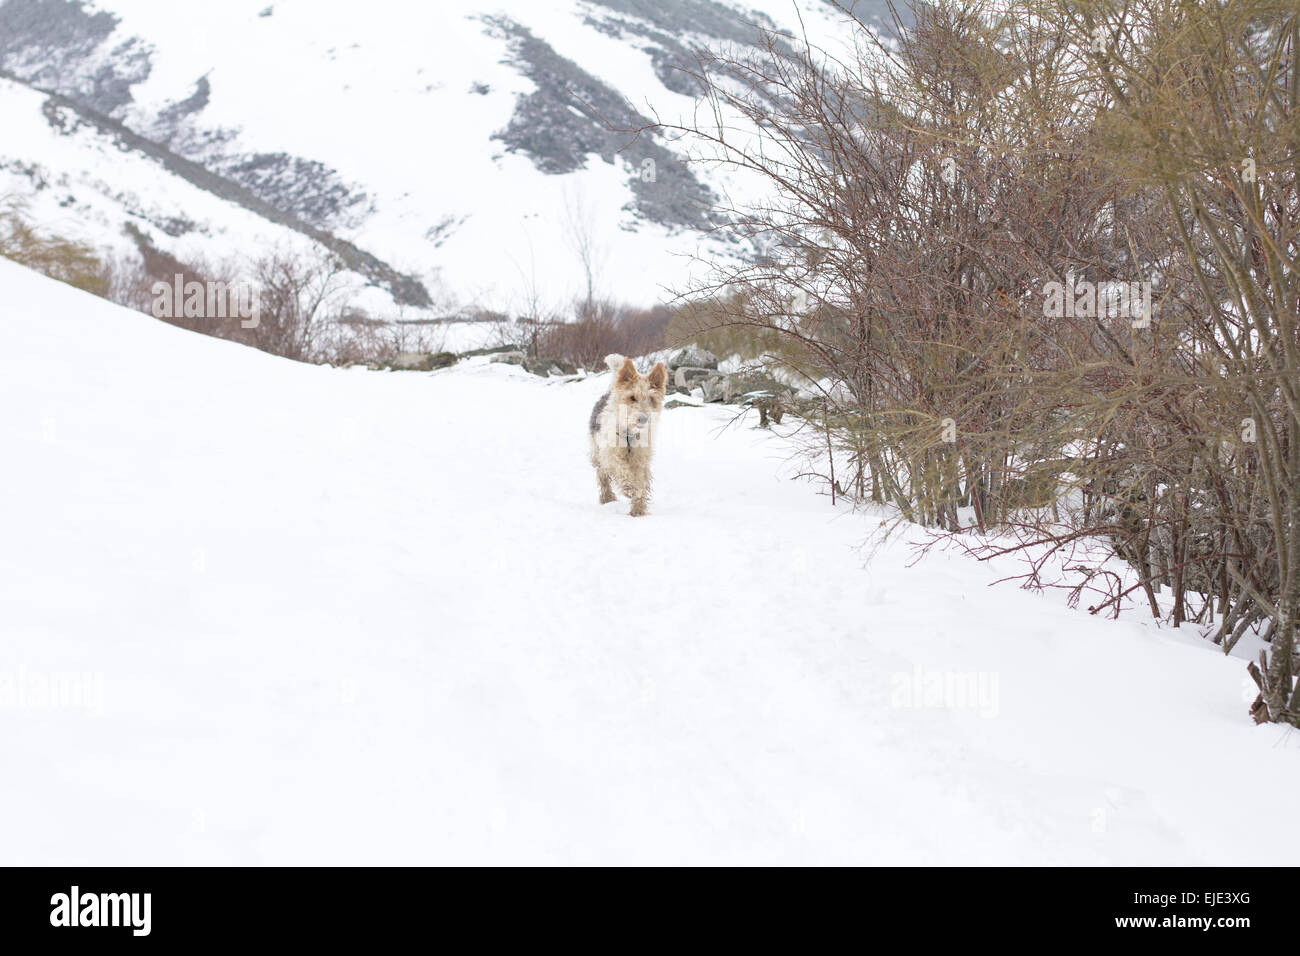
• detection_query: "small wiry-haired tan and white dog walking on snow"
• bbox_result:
[589,355,668,518]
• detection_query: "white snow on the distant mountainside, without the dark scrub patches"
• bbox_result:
[0,0,845,317]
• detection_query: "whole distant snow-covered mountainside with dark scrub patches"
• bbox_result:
[0,0,884,312]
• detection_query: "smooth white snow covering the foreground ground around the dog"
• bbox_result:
[0,260,1300,865]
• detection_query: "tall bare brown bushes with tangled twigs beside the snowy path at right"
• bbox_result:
[655,0,1300,724]
